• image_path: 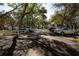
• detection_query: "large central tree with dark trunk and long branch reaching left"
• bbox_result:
[0,3,47,28]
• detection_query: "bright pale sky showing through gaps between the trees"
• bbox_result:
[0,3,56,20]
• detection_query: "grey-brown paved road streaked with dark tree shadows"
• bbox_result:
[0,30,79,55]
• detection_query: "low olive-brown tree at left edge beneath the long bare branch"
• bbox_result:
[0,13,15,29]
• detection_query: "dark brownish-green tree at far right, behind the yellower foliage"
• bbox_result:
[51,3,79,29]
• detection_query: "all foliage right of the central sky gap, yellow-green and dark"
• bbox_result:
[52,3,79,29]
